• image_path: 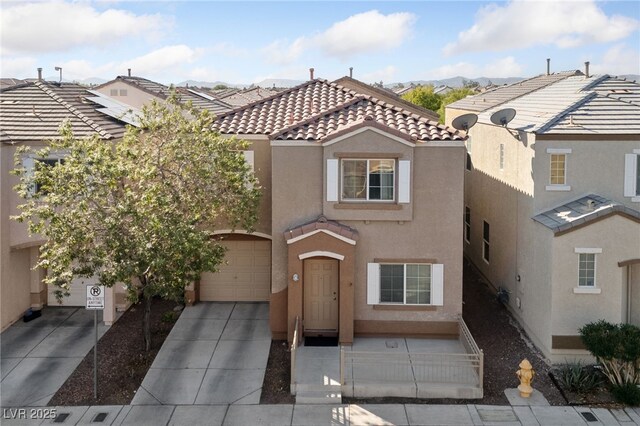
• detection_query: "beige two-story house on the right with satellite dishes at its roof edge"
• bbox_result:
[446,72,640,362]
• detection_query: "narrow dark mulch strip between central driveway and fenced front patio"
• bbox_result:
[260,340,295,404]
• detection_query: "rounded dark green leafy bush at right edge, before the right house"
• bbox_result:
[580,320,640,392]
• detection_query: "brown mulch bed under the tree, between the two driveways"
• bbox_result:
[49,299,180,406]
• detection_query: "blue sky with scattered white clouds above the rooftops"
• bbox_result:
[0,0,640,83]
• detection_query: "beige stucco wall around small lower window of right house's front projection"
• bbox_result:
[548,215,640,352]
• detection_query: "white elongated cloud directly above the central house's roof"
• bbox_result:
[262,10,416,64]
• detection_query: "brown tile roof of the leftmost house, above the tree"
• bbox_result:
[0,81,131,142]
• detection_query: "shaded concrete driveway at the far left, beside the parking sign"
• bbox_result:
[0,306,108,407]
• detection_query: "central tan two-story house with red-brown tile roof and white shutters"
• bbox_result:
[188,79,465,344]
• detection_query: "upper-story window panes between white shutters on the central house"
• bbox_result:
[342,159,396,201]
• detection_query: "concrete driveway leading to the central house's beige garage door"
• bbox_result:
[131,302,271,405]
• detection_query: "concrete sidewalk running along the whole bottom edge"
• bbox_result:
[0,404,640,426]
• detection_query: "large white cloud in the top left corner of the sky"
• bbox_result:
[0,1,172,53]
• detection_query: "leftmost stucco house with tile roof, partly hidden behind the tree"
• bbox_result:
[0,81,134,330]
